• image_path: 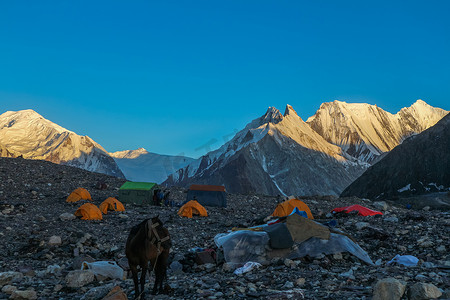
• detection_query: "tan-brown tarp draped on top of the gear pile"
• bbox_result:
[284,214,330,243]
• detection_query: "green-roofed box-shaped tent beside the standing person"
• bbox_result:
[119,181,157,204]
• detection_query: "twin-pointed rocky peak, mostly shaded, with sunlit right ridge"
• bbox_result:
[165,105,361,194]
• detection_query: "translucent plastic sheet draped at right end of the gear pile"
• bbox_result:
[288,233,373,265]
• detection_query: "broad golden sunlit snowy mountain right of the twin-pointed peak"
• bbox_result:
[307,100,447,162]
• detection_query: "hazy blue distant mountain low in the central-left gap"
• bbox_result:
[109,148,194,183]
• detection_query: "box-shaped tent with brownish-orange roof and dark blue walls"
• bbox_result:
[186,184,227,207]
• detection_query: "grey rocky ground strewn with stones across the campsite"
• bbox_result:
[0,158,450,299]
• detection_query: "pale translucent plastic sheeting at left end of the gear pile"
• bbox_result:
[214,230,269,265]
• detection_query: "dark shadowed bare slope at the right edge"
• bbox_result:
[342,114,450,199]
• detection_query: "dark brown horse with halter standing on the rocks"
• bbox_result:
[125,216,172,299]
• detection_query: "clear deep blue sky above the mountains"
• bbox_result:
[0,0,450,157]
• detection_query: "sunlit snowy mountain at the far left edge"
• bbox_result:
[0,109,124,178]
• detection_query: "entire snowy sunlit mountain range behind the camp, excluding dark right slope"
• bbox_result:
[0,100,448,195]
